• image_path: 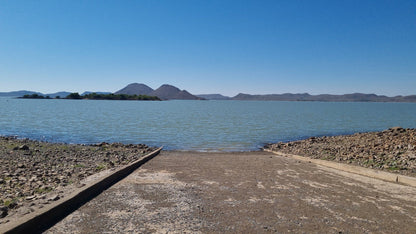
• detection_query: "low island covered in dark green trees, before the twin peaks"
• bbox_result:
[20,93,161,101]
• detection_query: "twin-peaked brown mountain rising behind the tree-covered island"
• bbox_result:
[115,83,202,100]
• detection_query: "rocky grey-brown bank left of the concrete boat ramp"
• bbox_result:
[0,137,155,224]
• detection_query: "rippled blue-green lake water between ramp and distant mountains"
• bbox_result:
[0,98,416,151]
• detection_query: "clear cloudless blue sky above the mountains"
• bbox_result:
[0,0,416,96]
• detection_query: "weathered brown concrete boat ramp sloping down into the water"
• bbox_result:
[48,152,416,233]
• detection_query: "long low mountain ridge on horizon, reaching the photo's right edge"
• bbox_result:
[232,93,416,102]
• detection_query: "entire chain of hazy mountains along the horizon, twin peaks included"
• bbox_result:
[0,83,416,102]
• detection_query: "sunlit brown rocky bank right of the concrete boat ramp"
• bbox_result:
[265,127,416,176]
